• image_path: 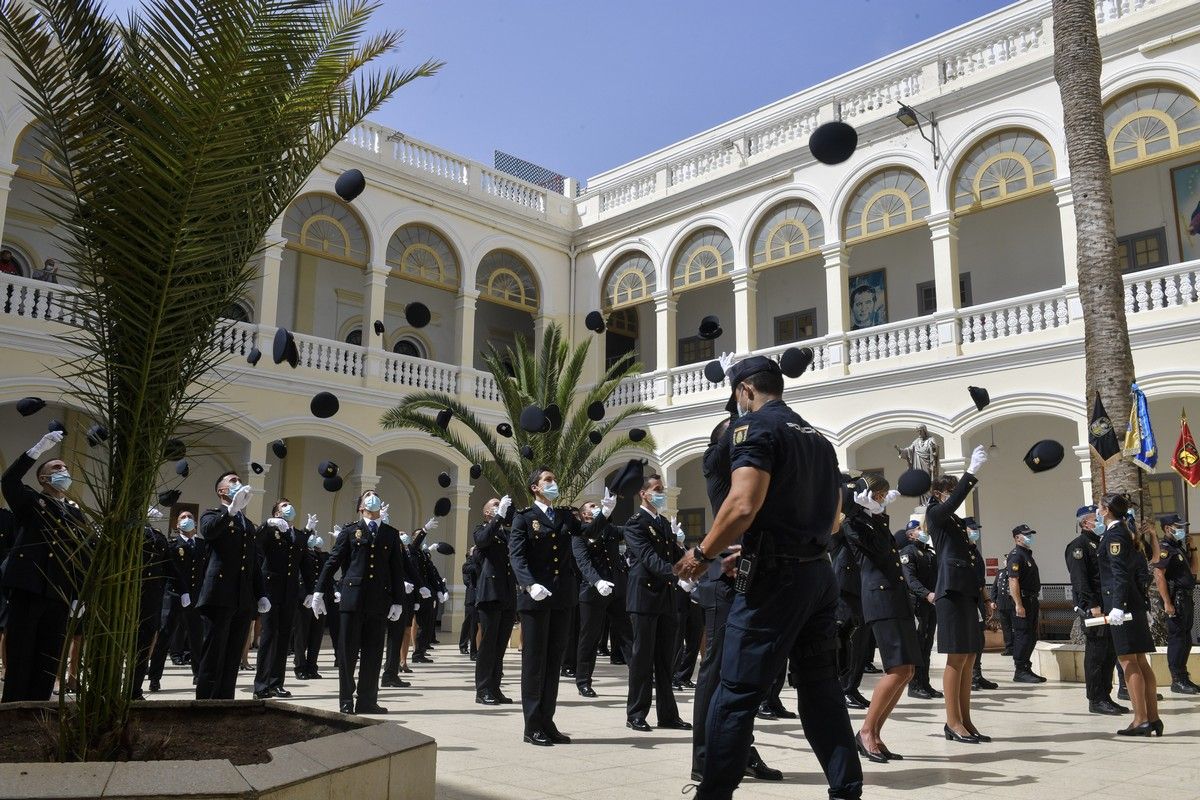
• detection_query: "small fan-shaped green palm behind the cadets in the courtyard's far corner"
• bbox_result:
[380,324,654,504]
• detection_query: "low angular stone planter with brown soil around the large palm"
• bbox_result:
[0,700,437,800]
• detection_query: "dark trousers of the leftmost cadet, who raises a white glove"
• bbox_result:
[0,589,68,703]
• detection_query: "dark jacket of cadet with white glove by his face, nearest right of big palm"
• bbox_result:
[192,506,266,614]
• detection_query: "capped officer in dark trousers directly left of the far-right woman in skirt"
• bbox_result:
[1063,505,1129,715]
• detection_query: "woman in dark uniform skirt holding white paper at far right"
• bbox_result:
[1096,494,1163,736]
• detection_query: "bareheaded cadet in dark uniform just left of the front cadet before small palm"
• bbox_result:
[472,494,517,705]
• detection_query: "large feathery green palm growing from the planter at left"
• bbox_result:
[0,0,440,760]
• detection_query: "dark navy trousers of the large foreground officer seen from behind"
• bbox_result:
[696,559,863,800]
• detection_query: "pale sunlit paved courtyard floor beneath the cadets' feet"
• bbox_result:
[152,647,1200,800]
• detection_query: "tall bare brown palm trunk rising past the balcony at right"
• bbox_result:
[1054,0,1138,493]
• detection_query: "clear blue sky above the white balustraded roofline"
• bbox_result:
[110,0,1008,178]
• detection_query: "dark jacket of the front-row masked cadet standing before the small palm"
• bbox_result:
[509,505,580,612]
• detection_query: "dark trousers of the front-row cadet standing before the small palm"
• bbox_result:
[518,609,571,735]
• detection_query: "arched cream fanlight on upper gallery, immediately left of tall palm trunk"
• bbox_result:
[954,131,1055,211]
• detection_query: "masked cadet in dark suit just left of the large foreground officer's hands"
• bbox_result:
[625,475,691,733]
